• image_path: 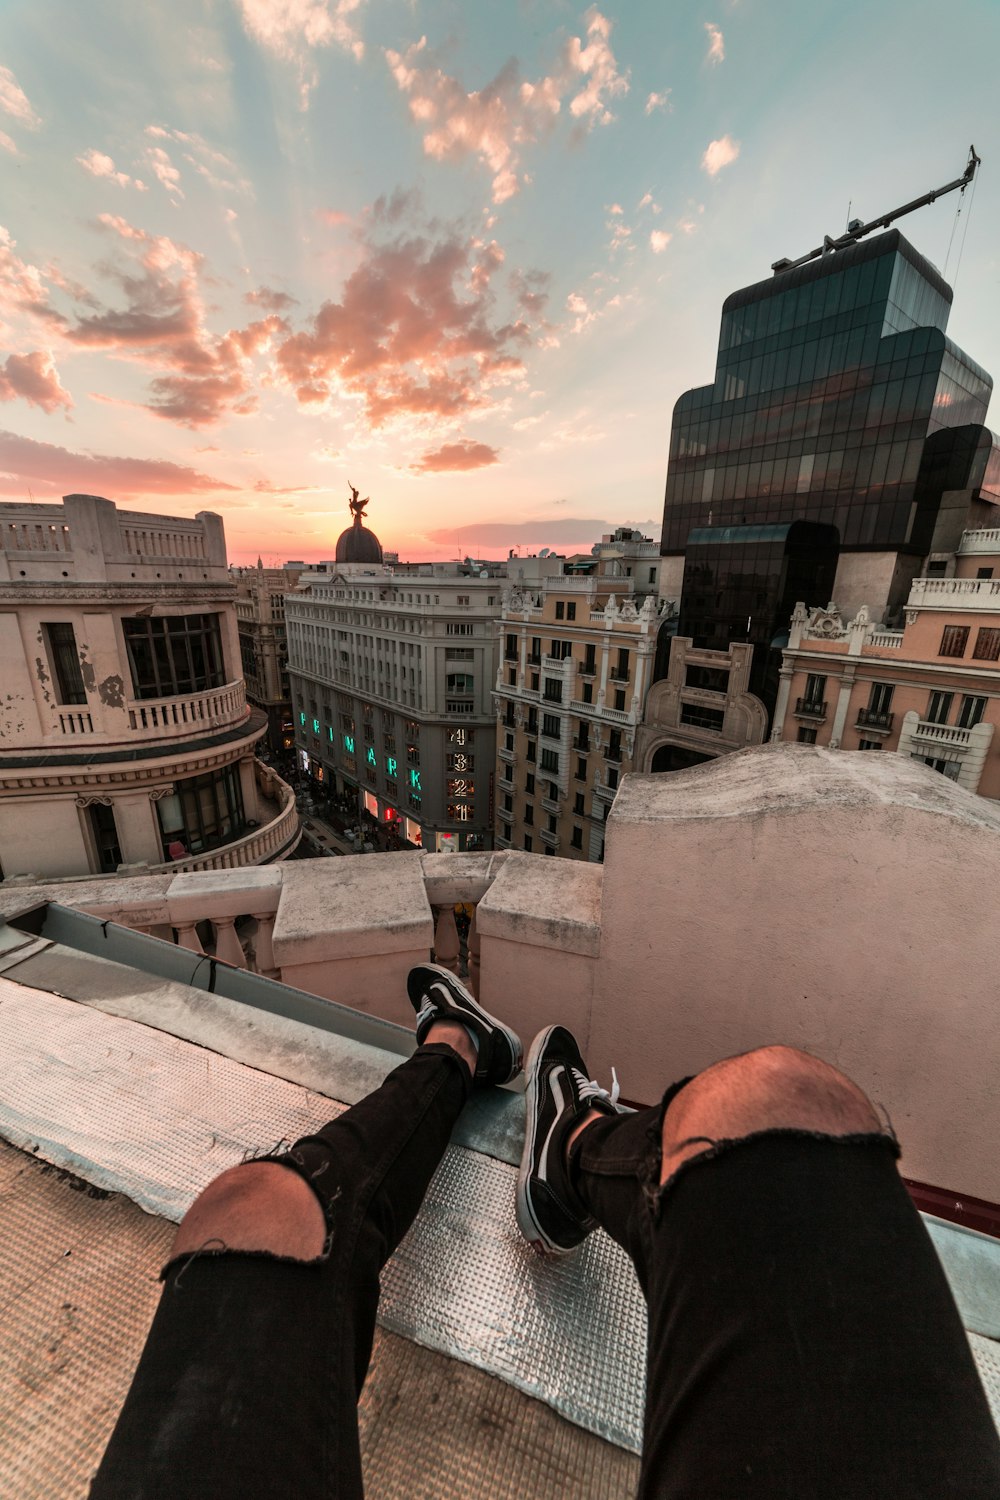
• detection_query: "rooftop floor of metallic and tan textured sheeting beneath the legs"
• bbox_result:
[0,882,1000,1500]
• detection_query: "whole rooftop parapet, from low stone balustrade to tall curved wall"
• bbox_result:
[0,744,1000,1203]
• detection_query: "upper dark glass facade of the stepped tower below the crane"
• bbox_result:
[660,230,993,561]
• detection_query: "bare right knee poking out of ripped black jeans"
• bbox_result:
[660,1046,882,1182]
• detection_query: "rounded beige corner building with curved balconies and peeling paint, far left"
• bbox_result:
[0,495,298,879]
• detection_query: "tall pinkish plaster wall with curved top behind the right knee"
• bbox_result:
[591,744,1000,1202]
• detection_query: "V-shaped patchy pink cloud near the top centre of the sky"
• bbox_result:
[385,11,628,204]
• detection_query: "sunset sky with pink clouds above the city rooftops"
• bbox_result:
[0,0,1000,564]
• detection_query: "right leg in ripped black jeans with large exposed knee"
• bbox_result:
[522,1044,1000,1500]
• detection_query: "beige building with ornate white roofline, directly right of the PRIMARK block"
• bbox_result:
[495,531,667,861]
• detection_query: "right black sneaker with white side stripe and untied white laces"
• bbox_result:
[517,1026,625,1256]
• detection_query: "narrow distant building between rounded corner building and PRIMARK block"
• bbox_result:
[229,558,304,755]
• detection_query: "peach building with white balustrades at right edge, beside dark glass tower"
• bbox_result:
[771,528,1000,798]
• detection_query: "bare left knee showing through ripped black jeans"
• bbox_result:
[172,1161,327,1260]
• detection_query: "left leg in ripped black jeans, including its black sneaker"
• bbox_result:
[91,966,520,1500]
